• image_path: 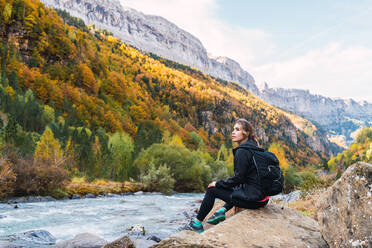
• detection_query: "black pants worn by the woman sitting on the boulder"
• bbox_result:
[196,187,269,221]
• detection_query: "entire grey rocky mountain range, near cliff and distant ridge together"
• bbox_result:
[38,0,372,148]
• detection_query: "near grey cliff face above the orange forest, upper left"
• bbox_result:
[42,0,258,93]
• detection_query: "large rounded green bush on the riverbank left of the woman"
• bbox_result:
[134,144,211,192]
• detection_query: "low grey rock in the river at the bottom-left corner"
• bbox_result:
[8,230,56,247]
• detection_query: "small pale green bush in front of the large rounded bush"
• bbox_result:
[141,164,175,194]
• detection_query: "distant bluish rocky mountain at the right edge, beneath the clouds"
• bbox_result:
[259,84,372,148]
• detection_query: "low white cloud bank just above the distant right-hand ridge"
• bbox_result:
[252,43,372,102]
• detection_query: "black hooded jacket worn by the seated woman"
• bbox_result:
[216,141,266,201]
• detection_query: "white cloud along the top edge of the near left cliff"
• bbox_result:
[123,0,274,67]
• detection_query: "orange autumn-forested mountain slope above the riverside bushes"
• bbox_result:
[0,0,331,174]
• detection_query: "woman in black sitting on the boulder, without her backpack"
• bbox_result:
[181,119,269,233]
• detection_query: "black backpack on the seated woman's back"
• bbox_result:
[243,149,284,196]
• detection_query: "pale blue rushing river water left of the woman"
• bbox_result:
[0,194,203,242]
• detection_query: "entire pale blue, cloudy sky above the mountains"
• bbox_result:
[122,0,372,103]
